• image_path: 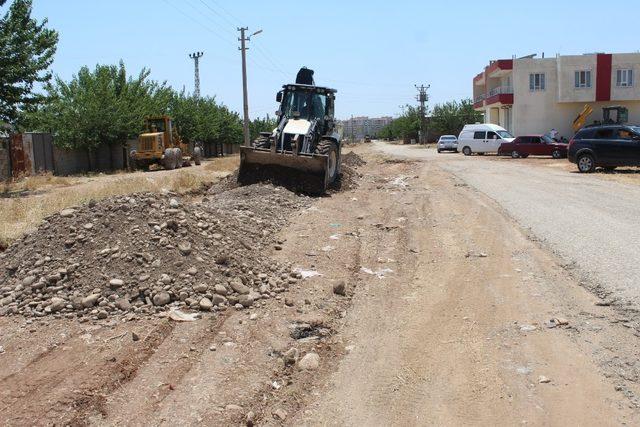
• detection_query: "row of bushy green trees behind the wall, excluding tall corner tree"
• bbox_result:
[25,62,248,150]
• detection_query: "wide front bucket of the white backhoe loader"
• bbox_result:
[238,147,328,195]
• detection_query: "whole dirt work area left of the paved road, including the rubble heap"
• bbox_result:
[0,144,640,426]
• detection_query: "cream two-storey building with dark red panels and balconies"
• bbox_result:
[473,53,640,138]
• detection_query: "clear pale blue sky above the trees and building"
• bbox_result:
[13,0,640,118]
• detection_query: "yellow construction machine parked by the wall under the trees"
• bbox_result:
[129,116,202,169]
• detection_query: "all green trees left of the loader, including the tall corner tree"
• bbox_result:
[0,0,275,150]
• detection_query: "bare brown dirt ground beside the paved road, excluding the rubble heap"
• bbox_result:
[0,147,640,426]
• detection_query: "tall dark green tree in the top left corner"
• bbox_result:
[0,0,58,124]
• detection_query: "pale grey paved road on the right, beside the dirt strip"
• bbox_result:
[374,142,640,307]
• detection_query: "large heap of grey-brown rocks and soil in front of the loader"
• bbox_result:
[0,184,309,319]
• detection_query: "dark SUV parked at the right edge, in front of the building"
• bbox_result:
[568,125,640,172]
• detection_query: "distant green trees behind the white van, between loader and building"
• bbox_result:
[378,99,482,140]
